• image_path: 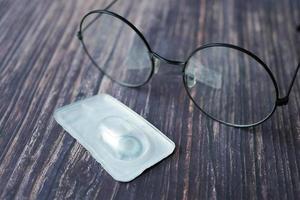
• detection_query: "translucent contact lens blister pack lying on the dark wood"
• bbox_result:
[54,94,175,182]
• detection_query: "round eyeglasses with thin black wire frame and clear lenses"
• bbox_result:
[77,1,300,127]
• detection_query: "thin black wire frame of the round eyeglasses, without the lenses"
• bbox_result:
[77,5,300,128]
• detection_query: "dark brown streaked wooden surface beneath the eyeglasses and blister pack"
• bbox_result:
[0,0,300,200]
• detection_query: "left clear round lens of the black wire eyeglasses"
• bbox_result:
[82,13,152,87]
